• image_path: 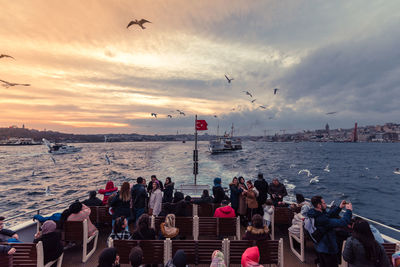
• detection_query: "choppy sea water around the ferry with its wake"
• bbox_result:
[0,142,400,239]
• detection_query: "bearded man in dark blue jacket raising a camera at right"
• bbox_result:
[308,196,353,267]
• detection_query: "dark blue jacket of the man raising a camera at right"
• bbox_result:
[307,206,352,254]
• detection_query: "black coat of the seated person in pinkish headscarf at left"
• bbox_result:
[33,231,64,264]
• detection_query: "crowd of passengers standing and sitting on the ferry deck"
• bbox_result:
[0,173,396,267]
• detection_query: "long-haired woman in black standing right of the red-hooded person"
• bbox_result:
[111,182,131,222]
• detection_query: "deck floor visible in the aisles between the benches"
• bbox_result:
[62,225,316,267]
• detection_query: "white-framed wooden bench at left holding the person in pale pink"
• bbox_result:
[62,220,99,263]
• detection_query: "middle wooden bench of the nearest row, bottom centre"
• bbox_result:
[168,240,224,265]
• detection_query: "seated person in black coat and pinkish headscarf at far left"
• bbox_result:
[33,220,64,265]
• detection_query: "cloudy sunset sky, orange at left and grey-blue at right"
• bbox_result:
[0,0,400,135]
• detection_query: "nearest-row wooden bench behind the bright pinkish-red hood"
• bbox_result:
[225,238,284,267]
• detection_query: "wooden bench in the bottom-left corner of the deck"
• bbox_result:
[0,241,64,267]
